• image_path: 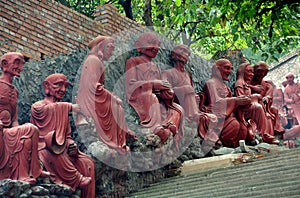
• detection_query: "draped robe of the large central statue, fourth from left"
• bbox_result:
[125,57,183,137]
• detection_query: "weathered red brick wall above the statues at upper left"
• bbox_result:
[0,0,138,60]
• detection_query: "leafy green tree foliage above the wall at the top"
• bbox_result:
[54,0,300,61]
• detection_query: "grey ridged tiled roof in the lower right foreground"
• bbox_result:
[129,148,300,198]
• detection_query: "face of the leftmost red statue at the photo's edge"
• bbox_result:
[2,54,25,77]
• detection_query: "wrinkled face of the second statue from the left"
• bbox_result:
[48,78,69,100]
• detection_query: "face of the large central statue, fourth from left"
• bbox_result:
[140,37,160,58]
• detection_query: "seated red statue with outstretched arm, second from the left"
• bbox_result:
[30,74,95,197]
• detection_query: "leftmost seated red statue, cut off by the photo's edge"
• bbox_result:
[0,52,50,184]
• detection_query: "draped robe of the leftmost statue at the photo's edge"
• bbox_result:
[0,80,42,181]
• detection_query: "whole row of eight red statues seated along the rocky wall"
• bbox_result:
[0,33,290,197]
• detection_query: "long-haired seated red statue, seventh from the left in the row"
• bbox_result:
[234,63,279,144]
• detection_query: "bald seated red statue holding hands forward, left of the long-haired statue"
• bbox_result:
[203,59,255,148]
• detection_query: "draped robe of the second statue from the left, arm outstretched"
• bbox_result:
[30,100,95,198]
